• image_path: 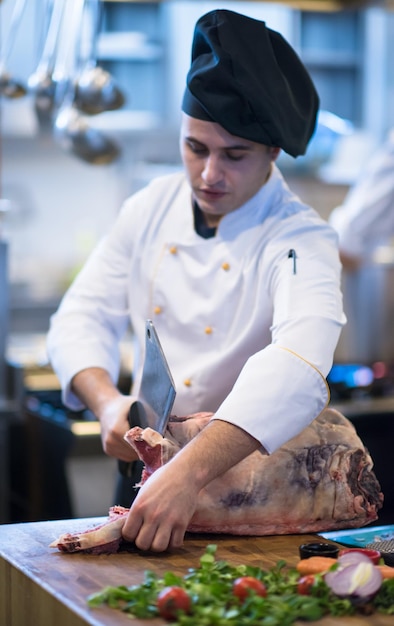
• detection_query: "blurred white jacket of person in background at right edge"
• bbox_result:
[329,129,394,261]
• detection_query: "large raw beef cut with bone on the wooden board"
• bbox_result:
[51,409,383,553]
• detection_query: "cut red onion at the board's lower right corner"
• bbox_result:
[324,552,383,603]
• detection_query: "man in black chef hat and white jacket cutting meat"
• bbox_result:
[48,10,345,551]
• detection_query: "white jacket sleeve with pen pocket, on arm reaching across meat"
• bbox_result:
[213,221,346,453]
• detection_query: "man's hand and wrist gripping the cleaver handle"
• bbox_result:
[72,367,138,462]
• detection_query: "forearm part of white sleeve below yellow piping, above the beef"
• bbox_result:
[213,324,339,453]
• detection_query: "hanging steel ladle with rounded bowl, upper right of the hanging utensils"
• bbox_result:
[75,0,125,115]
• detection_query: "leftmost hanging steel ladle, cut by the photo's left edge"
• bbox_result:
[0,0,27,99]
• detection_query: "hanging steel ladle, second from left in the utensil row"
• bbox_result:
[27,0,65,124]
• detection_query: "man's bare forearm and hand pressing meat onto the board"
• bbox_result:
[122,420,264,552]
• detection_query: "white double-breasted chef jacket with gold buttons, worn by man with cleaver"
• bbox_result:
[48,166,345,452]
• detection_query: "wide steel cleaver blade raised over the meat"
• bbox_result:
[128,320,176,435]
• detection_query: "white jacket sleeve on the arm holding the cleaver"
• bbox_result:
[47,199,132,410]
